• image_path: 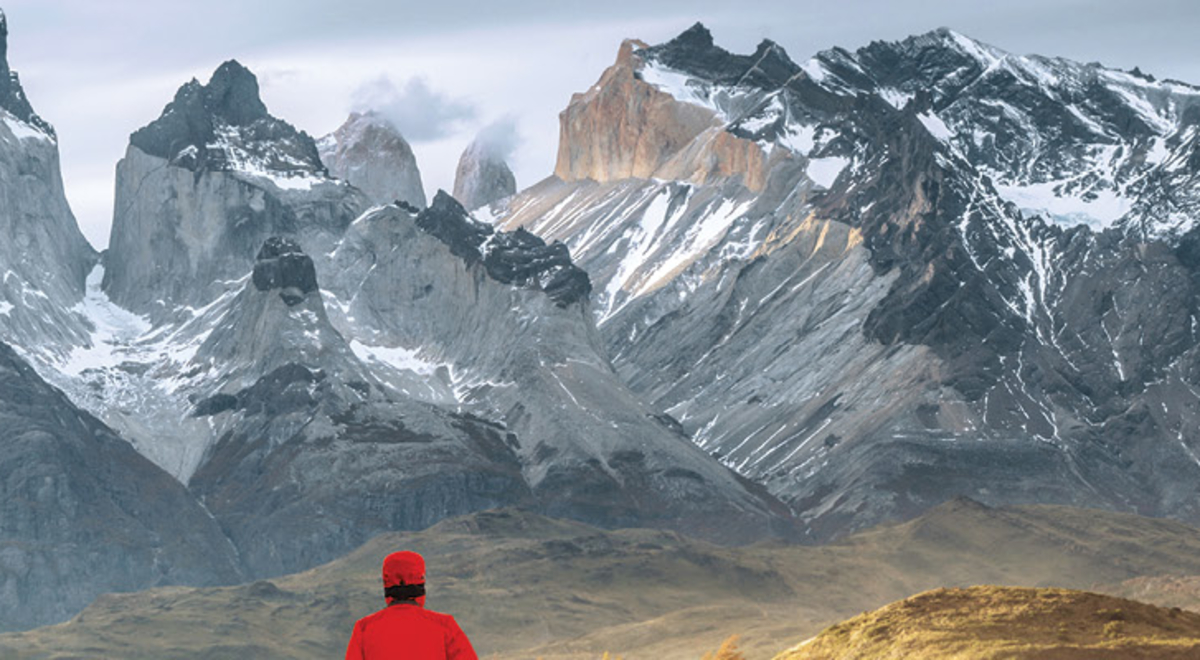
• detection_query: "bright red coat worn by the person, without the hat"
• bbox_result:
[346,601,476,660]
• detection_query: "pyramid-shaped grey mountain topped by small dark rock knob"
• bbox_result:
[178,238,529,576]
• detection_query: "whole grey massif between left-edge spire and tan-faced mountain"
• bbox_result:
[0,49,796,623]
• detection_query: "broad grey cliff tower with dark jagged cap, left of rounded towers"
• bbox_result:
[103,61,370,320]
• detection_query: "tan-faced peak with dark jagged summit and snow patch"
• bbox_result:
[554,24,777,190]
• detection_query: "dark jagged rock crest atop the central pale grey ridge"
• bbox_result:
[416,190,592,307]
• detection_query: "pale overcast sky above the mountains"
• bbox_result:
[2,0,1200,247]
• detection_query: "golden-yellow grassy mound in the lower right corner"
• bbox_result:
[776,587,1200,660]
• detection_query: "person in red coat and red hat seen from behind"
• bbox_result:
[346,552,478,660]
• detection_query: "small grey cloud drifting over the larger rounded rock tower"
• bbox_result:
[352,77,478,142]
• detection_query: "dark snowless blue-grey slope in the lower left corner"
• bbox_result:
[0,343,244,630]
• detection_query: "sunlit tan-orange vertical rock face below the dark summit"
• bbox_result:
[554,40,767,190]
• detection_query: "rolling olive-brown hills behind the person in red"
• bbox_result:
[7,502,1200,660]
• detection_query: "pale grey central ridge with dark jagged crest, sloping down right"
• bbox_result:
[319,201,786,549]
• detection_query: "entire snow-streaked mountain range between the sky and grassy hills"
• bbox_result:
[0,10,1200,630]
